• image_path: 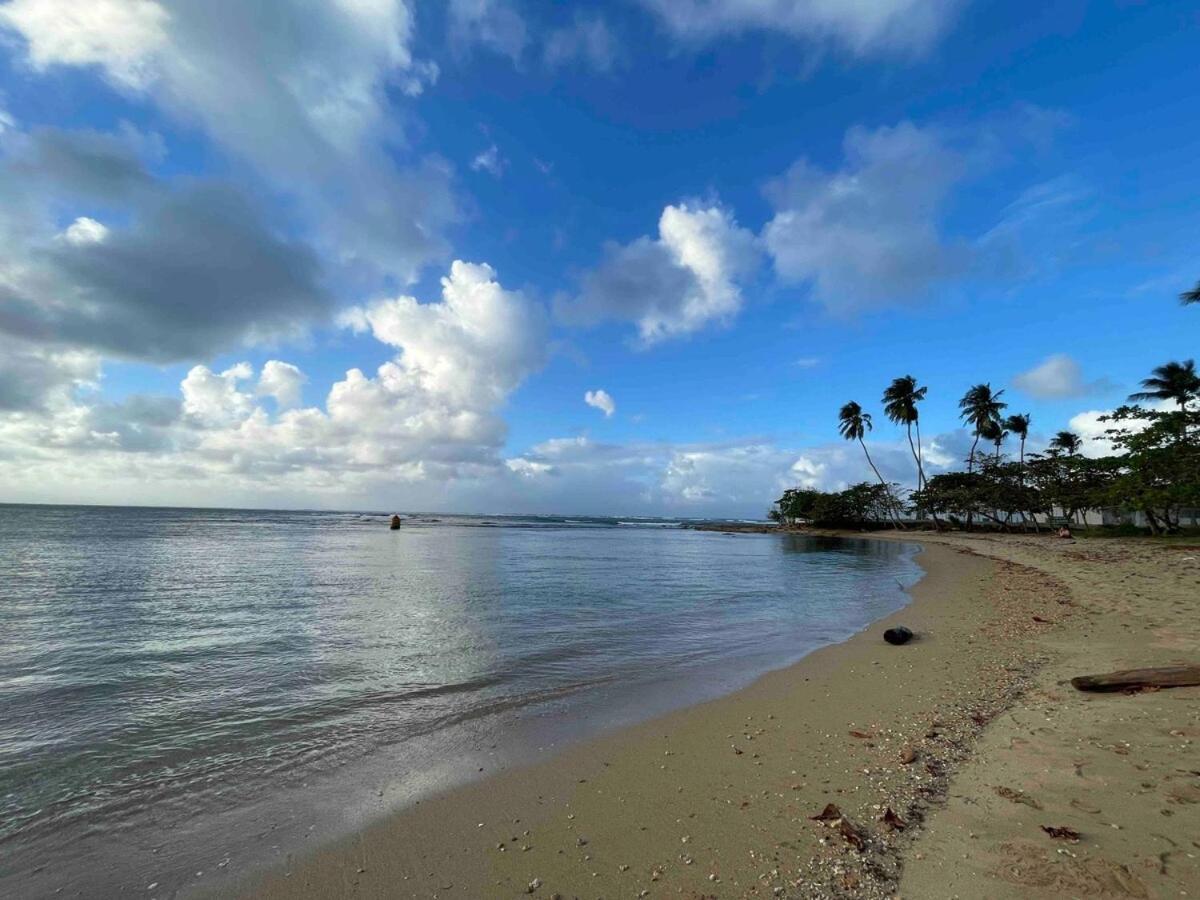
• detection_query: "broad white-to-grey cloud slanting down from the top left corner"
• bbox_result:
[0,0,458,281]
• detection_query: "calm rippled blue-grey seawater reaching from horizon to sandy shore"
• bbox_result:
[0,505,919,896]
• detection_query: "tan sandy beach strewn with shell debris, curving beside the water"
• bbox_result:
[238,534,1200,898]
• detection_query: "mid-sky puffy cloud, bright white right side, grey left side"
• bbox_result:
[556,204,758,346]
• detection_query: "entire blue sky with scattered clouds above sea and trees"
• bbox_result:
[0,0,1200,518]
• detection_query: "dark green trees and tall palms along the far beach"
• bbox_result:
[769,282,1200,534]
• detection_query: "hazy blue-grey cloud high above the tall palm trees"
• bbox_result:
[763,122,972,311]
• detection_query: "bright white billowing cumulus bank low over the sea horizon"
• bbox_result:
[0,262,546,508]
